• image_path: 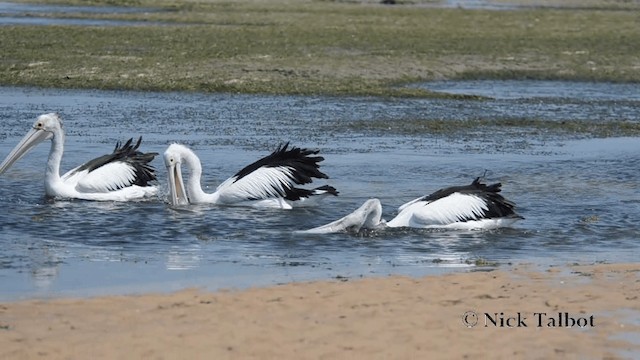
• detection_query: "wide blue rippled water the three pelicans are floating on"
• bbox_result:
[0,82,640,300]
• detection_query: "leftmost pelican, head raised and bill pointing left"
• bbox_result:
[0,113,158,201]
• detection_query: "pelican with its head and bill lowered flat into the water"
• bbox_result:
[297,178,523,234]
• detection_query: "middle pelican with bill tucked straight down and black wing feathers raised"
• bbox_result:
[164,143,338,209]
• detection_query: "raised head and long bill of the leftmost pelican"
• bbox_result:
[0,113,62,174]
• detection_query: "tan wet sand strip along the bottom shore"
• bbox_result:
[0,264,640,359]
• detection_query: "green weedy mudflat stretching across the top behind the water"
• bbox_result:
[0,0,640,97]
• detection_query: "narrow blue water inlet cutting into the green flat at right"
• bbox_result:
[412,80,640,123]
